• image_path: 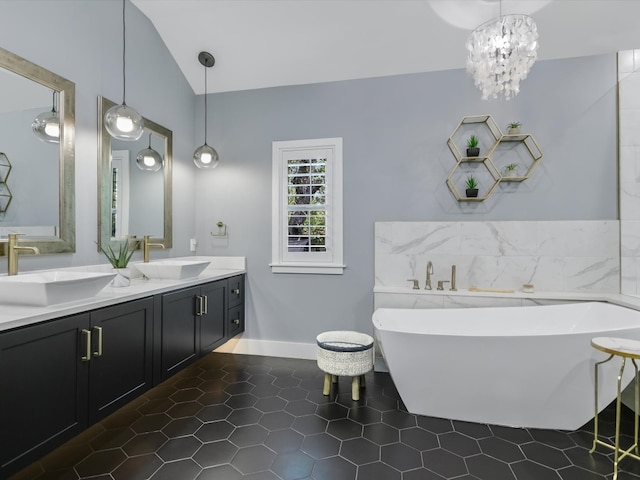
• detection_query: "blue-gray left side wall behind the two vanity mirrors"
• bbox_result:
[0,0,197,273]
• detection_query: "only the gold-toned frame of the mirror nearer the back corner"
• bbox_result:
[98,97,173,250]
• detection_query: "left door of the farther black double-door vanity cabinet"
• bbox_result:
[161,287,200,380]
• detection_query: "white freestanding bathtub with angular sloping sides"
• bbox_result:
[373,302,640,430]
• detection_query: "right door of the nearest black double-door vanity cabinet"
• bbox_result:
[89,298,153,423]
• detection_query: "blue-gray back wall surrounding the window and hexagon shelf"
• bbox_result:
[196,54,617,342]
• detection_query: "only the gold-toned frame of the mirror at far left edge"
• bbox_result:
[0,48,76,255]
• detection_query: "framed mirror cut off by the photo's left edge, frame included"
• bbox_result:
[0,48,75,255]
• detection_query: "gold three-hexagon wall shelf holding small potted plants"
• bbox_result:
[446,115,544,202]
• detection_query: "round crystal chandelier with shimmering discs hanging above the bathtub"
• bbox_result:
[467,15,538,100]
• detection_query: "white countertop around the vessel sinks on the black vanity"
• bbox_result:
[0,256,246,331]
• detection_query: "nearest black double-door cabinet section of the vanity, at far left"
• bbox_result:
[0,298,153,478]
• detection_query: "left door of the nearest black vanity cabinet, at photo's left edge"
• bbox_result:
[0,314,89,478]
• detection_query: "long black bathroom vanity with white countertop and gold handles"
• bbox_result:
[0,259,245,478]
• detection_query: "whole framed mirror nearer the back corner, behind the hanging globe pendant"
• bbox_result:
[98,97,173,248]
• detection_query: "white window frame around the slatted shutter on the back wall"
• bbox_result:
[269,138,345,275]
